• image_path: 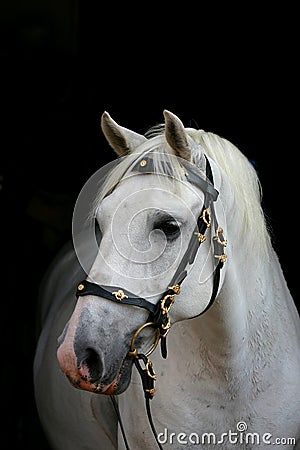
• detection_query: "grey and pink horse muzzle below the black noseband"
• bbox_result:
[57,297,138,394]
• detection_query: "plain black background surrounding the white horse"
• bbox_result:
[0,0,299,449]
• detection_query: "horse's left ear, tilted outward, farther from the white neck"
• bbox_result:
[101,111,147,156]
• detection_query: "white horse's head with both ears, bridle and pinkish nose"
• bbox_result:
[57,111,227,394]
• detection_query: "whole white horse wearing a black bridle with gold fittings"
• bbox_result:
[34,111,300,450]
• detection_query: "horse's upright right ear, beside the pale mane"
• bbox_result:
[164,109,191,161]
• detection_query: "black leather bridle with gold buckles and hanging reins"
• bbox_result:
[76,156,227,449]
